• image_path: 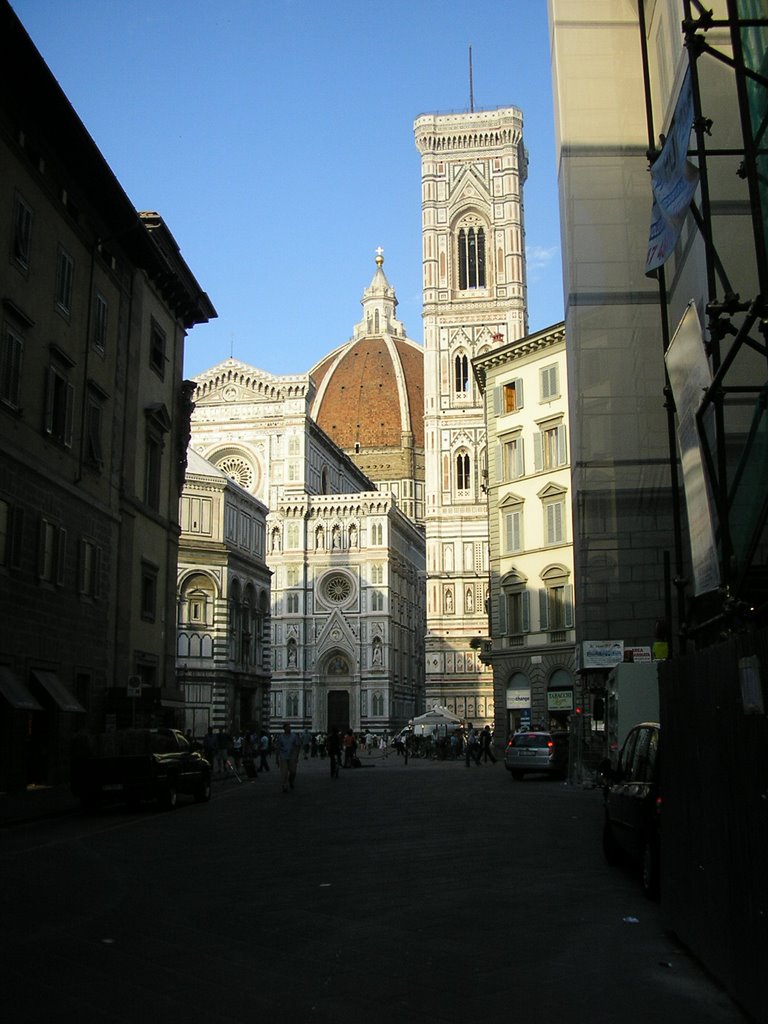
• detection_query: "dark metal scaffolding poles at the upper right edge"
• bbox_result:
[638,0,768,646]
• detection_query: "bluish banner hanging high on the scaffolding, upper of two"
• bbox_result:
[645,71,698,273]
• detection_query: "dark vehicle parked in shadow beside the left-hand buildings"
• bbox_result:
[72,729,211,810]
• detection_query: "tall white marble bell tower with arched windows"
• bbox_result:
[414,106,527,724]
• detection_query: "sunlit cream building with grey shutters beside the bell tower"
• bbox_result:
[473,324,582,740]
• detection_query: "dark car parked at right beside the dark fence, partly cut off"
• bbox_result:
[600,722,662,899]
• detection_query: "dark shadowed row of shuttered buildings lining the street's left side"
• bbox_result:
[0,2,216,790]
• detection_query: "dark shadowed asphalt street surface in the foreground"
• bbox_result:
[0,755,744,1024]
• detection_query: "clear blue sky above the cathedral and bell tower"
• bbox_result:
[11,0,562,377]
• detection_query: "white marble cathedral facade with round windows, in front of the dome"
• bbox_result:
[186,303,425,732]
